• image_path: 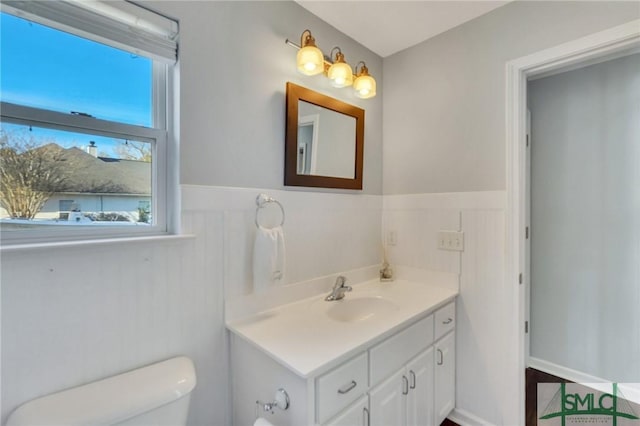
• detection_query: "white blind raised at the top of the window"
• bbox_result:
[2,0,178,63]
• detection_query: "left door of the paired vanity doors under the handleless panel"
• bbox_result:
[369,368,402,426]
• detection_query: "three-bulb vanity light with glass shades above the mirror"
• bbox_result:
[285,30,376,99]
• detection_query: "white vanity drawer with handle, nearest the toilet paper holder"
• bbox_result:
[316,353,369,423]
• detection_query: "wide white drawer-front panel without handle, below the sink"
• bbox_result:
[369,315,433,386]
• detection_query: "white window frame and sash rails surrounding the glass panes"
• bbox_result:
[0,0,179,247]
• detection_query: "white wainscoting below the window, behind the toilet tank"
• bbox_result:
[1,230,229,425]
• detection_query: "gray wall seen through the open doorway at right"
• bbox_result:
[529,54,640,382]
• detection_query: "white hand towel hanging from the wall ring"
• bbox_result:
[253,226,285,293]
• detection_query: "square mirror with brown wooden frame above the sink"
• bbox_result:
[284,82,364,189]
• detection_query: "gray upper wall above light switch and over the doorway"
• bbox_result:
[383,1,640,194]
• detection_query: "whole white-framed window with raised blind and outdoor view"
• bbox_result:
[0,0,177,244]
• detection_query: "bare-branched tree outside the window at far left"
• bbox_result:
[0,130,68,219]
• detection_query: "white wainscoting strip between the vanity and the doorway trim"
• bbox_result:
[456,210,508,424]
